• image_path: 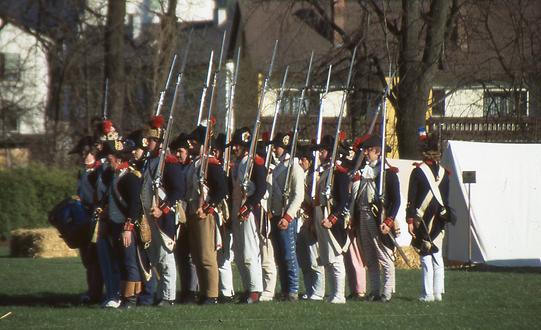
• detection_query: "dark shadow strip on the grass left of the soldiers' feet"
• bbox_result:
[0,292,84,308]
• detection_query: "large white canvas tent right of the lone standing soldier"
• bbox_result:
[442,141,541,266]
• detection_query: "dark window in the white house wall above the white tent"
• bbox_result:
[483,91,528,117]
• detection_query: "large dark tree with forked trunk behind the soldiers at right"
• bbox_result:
[292,0,459,158]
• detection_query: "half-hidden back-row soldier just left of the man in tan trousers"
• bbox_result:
[169,133,199,304]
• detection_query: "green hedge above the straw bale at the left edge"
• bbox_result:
[0,165,77,239]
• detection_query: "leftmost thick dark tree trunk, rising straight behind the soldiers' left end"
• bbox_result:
[105,0,126,130]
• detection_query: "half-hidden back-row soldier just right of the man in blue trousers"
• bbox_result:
[297,146,325,300]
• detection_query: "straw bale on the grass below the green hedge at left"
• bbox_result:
[10,228,78,258]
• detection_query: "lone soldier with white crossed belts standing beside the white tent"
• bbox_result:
[406,134,450,302]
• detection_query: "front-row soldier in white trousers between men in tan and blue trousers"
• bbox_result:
[229,127,267,304]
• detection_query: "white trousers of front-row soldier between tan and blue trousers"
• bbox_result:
[232,213,263,292]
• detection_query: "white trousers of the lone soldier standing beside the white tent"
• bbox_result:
[421,249,444,298]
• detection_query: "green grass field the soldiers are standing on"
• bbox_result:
[0,247,541,329]
